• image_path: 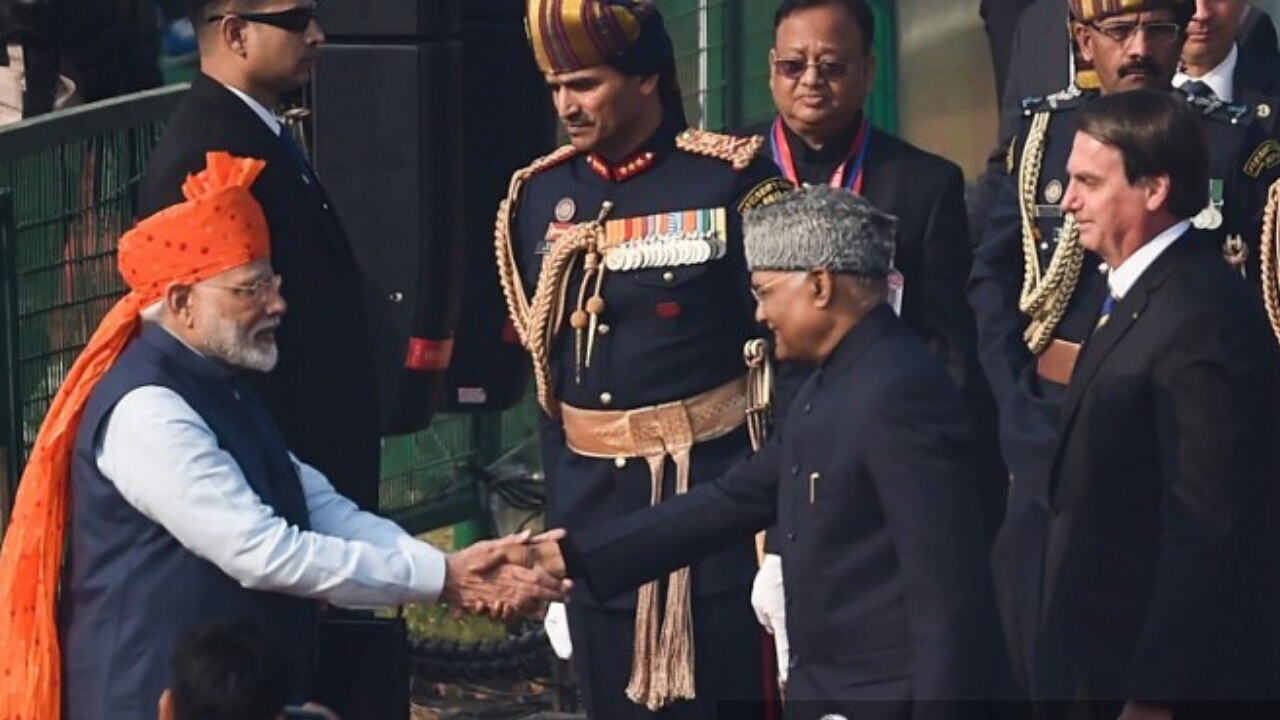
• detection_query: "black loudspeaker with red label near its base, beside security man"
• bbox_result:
[312,40,465,434]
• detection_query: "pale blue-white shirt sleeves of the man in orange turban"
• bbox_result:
[95,386,445,607]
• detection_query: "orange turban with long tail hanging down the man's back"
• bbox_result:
[0,152,270,720]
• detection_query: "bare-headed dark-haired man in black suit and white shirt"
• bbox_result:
[1032,91,1280,720]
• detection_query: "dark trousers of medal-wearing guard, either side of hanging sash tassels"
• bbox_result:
[568,587,765,720]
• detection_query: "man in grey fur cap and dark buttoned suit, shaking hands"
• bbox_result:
[524,187,1001,720]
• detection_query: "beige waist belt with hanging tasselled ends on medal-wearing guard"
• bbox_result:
[561,378,746,711]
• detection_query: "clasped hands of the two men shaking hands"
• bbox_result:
[440,529,573,620]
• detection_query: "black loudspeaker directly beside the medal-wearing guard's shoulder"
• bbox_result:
[444,0,556,411]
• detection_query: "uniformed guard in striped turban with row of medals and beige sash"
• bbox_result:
[495,0,790,720]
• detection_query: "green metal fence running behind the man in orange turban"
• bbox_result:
[0,86,536,532]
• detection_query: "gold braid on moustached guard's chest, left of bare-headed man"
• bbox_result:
[1018,111,1084,355]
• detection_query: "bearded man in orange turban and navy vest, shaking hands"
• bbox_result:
[0,152,563,720]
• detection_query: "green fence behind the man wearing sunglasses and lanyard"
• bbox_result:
[658,0,897,132]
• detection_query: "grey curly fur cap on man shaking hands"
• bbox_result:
[742,186,897,278]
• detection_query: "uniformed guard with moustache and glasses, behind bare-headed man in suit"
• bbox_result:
[968,0,1267,683]
